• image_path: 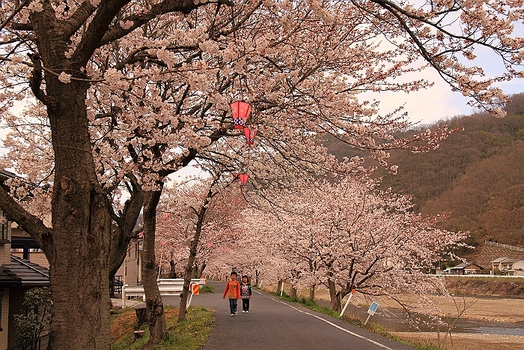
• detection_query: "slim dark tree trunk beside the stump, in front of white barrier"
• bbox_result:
[142,190,167,346]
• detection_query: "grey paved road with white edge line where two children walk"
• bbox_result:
[165,281,413,350]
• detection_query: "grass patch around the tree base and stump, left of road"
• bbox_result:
[111,306,215,350]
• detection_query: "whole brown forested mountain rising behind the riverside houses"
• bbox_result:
[326,94,524,252]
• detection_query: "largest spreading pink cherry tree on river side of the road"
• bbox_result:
[242,176,467,310]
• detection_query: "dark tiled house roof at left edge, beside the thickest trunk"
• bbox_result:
[0,255,49,288]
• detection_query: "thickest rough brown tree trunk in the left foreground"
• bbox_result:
[42,78,111,349]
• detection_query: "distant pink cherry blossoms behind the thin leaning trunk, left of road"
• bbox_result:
[156,178,246,284]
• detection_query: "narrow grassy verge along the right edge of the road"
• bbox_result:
[272,292,446,350]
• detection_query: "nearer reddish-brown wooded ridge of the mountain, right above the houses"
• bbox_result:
[421,141,524,245]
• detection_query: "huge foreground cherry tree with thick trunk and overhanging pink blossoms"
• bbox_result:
[0,0,522,349]
